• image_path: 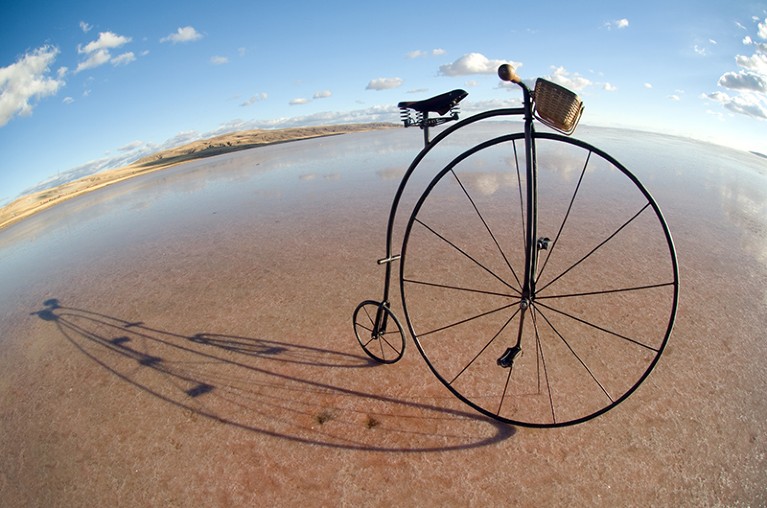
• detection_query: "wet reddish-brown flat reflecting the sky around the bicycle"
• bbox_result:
[0,128,767,506]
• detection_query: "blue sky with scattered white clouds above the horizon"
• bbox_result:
[0,0,767,204]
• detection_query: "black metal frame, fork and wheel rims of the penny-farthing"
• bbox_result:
[353,76,679,427]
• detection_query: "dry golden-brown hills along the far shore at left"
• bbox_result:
[0,123,399,231]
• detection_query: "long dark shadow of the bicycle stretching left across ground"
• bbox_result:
[32,299,515,452]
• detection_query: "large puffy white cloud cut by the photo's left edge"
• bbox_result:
[0,46,64,127]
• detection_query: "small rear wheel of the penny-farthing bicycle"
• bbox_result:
[353,300,405,363]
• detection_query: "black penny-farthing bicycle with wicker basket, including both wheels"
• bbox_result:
[353,65,679,427]
